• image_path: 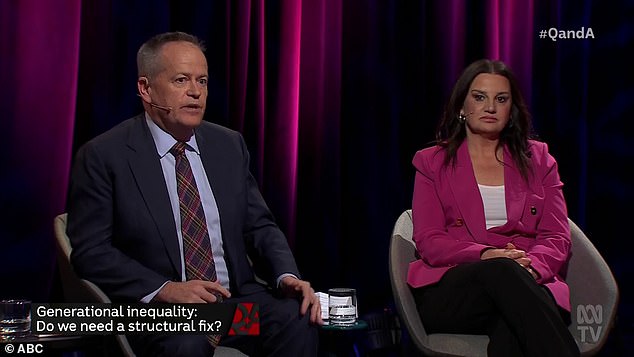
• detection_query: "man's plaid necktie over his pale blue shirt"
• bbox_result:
[170,142,220,347]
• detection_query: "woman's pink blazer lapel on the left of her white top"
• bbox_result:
[448,140,487,242]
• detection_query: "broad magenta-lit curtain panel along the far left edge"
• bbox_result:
[0,0,81,300]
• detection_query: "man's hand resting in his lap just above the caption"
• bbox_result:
[152,280,231,303]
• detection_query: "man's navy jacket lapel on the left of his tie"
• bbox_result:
[128,115,182,276]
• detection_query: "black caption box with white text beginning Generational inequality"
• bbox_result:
[31,303,236,335]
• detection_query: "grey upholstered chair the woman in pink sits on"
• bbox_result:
[389,210,619,356]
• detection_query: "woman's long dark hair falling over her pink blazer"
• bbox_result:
[436,59,534,180]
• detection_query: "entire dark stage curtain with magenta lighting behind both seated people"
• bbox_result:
[0,6,634,346]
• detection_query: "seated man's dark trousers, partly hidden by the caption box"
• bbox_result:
[128,291,318,357]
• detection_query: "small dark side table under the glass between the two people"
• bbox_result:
[319,319,368,357]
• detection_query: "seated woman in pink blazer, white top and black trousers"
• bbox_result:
[408,60,579,357]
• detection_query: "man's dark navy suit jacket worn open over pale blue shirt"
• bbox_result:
[67,115,300,301]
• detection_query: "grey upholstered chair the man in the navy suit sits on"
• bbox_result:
[53,213,246,357]
